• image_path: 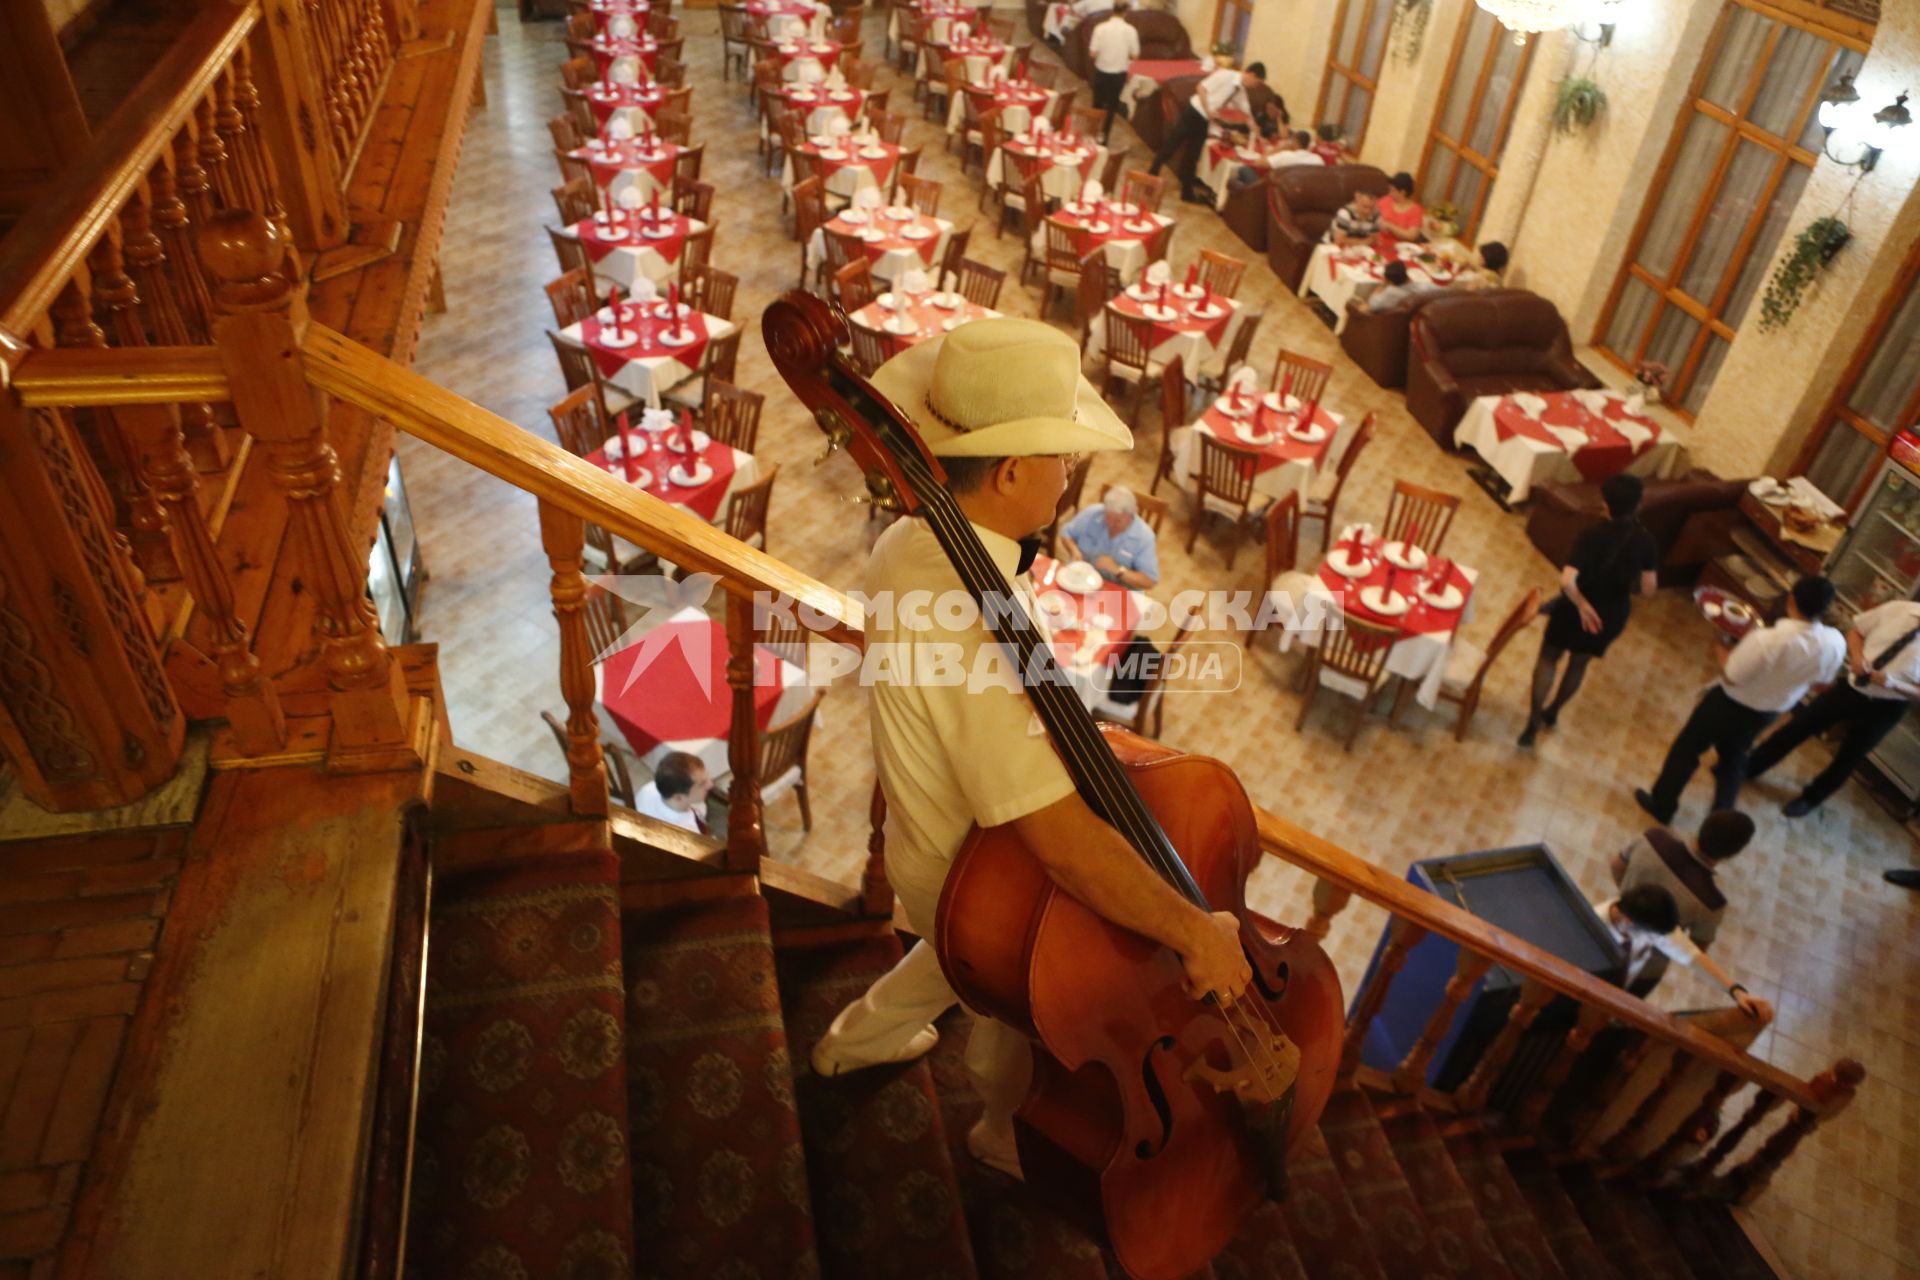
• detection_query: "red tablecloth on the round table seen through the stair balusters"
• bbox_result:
[601,618,785,756]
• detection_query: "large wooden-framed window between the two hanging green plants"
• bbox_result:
[1594,0,1866,416]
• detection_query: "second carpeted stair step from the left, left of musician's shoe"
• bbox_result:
[620,894,820,1280]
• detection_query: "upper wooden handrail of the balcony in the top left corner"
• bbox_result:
[0,0,259,336]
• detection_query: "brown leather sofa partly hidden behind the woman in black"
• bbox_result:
[1526,468,1747,587]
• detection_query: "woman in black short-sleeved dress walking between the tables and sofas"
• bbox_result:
[1521,476,1659,747]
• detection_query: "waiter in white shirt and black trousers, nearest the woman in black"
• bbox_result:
[1634,578,1847,827]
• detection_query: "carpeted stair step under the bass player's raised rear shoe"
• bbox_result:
[780,935,977,1280]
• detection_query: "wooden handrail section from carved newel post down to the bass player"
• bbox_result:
[303,324,866,649]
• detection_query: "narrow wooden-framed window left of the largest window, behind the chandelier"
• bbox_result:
[1419,6,1534,244]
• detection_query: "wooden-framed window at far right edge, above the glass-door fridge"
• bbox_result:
[1793,244,1920,510]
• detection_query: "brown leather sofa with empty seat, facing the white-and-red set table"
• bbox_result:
[1407,290,1601,449]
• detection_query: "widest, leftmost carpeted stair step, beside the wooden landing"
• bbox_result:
[407,833,636,1280]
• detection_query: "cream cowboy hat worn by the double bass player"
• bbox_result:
[874,319,1133,459]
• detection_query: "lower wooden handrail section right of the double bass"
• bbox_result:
[1254,806,1820,1107]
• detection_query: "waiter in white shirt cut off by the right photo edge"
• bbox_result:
[1747,601,1920,818]
